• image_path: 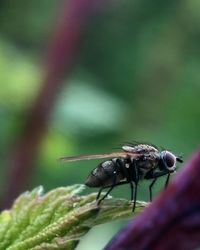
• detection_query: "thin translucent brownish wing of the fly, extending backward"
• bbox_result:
[59,152,138,162]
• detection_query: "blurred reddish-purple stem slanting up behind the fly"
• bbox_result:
[1,0,100,208]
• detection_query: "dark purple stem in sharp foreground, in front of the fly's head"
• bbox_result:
[105,151,200,250]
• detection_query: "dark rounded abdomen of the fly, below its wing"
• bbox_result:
[85,160,122,187]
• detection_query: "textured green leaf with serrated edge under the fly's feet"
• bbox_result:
[0,184,147,250]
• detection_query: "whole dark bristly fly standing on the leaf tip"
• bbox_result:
[61,144,182,211]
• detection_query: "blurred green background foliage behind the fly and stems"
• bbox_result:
[0,0,200,250]
